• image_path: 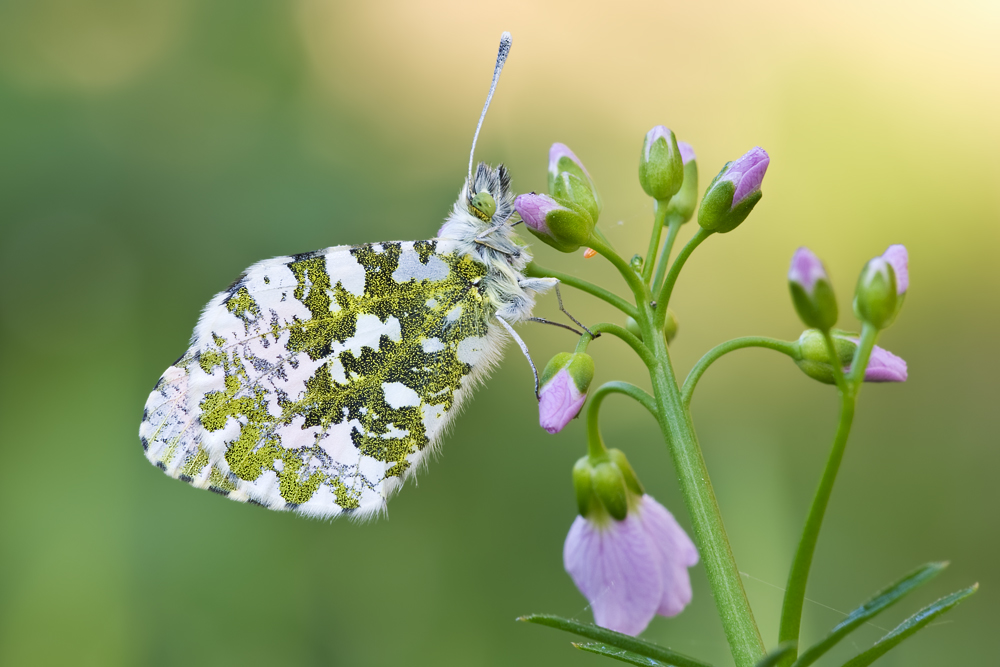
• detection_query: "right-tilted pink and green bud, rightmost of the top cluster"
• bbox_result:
[698,146,771,234]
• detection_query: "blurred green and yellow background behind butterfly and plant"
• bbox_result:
[0,0,1000,667]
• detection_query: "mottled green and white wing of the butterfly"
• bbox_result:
[139,240,502,517]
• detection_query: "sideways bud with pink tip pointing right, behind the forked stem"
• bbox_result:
[795,329,907,384]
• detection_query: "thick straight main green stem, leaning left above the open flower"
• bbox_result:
[639,304,764,667]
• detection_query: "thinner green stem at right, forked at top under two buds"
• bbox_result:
[778,323,878,664]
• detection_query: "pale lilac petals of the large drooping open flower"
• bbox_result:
[563,495,698,635]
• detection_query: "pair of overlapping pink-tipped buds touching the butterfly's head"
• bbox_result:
[514,143,601,252]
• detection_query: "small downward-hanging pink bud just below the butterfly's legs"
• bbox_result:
[538,352,594,433]
